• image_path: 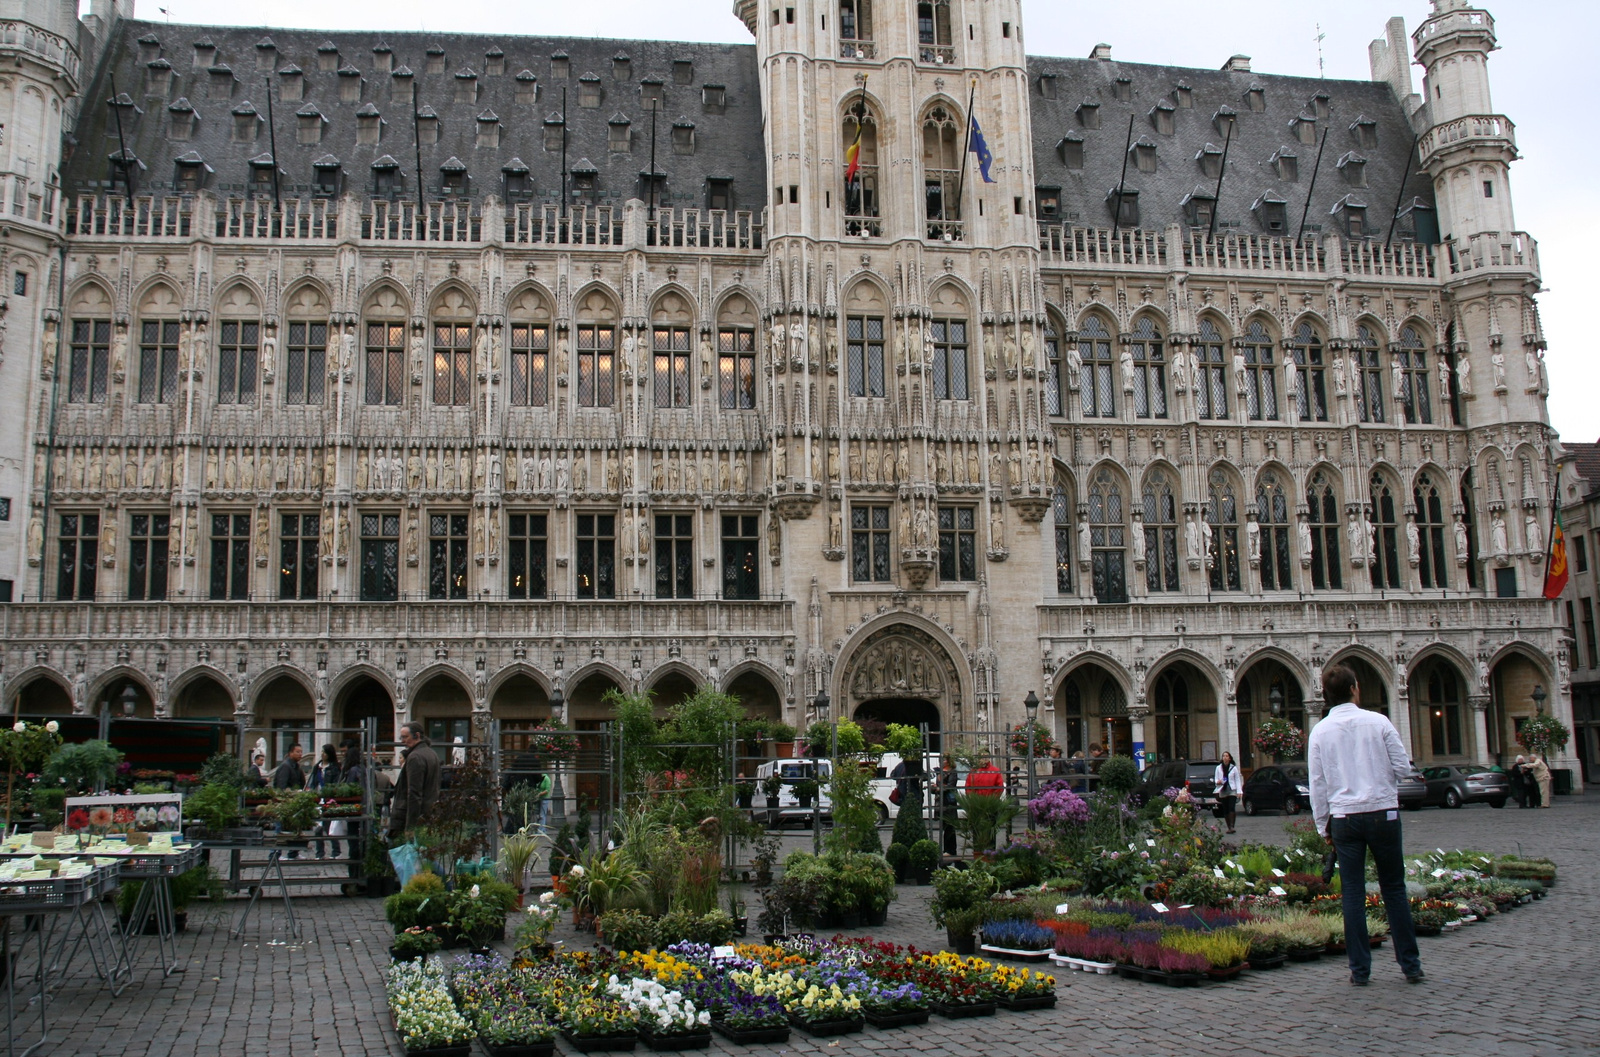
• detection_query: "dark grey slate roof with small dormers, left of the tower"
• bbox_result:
[64,19,766,209]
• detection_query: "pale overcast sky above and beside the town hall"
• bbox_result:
[118,0,1600,441]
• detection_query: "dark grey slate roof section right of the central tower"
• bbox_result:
[1024,56,1434,238]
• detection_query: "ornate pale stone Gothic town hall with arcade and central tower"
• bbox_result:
[0,0,1571,783]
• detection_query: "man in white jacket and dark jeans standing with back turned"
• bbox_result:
[1306,664,1422,987]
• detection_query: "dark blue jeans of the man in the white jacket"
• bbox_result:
[1333,809,1422,980]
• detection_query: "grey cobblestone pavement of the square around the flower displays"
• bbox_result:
[25,795,1600,1057]
